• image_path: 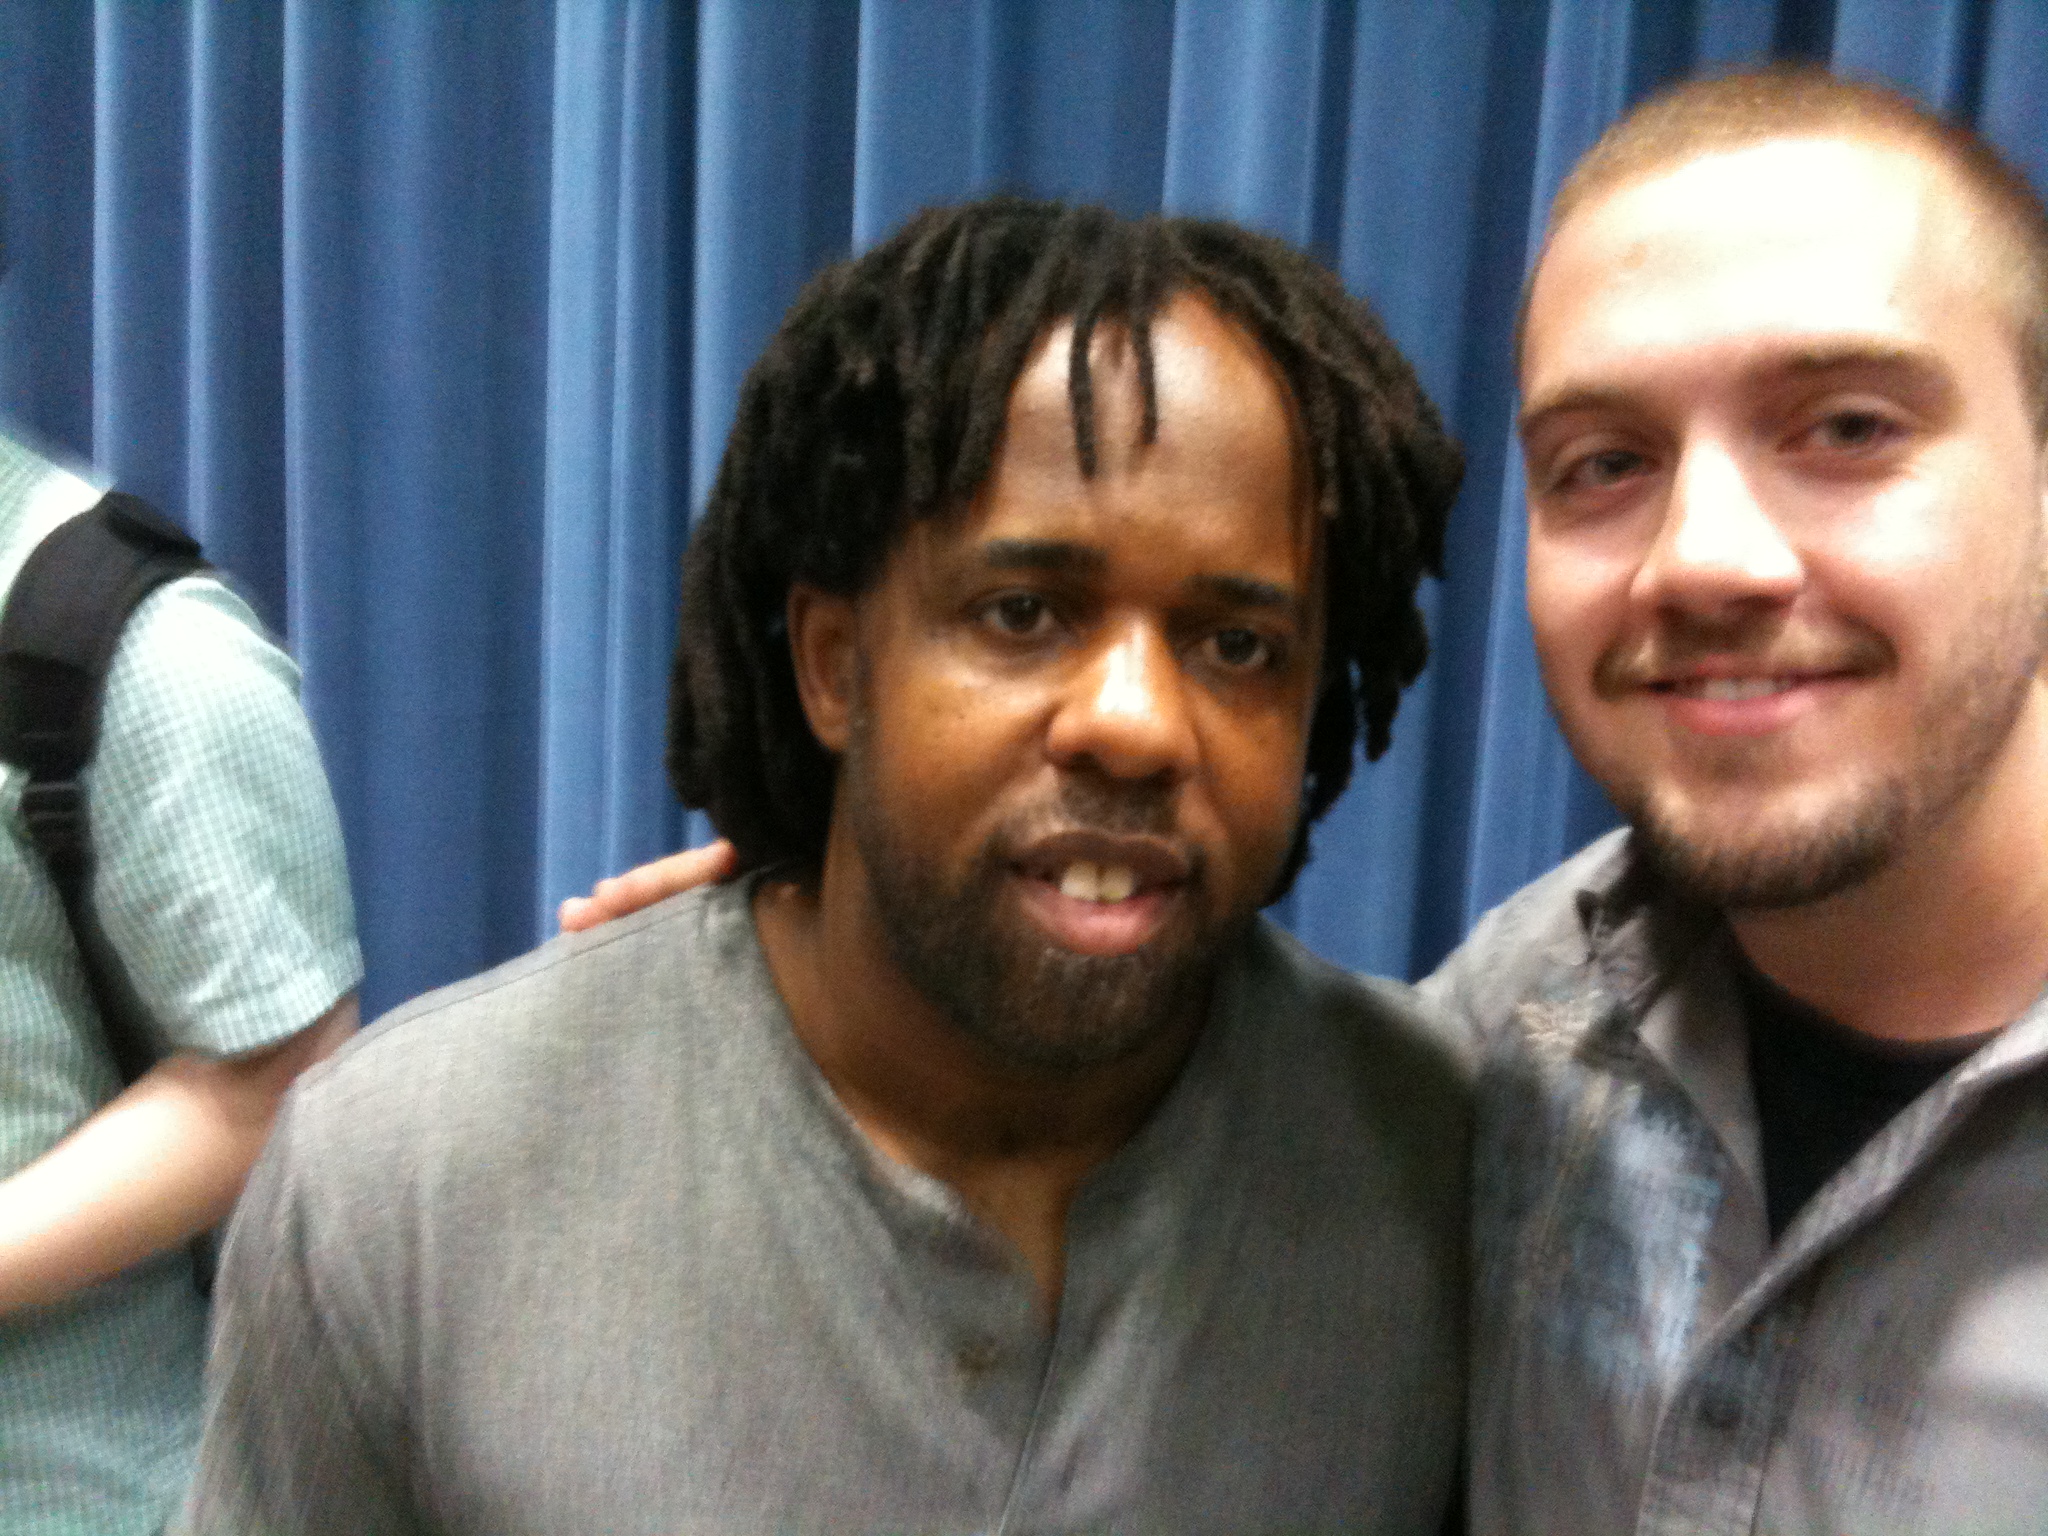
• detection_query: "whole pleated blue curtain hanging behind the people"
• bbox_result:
[0,0,2048,1024]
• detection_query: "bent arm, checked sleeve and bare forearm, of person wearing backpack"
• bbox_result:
[0,582,362,1317]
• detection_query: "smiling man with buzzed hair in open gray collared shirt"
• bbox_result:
[1432,72,2048,1532]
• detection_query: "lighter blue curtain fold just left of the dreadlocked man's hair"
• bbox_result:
[535,0,694,932]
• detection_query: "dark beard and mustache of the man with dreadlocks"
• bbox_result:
[840,741,1253,1073]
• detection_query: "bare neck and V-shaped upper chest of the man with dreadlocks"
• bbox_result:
[754,840,1202,1311]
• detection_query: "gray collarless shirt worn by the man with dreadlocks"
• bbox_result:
[190,887,1466,1536]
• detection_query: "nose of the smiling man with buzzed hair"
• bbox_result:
[1634,442,1804,614]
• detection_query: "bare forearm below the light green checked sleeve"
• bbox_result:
[0,993,356,1319]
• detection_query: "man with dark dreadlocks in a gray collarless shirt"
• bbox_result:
[172,201,1464,1536]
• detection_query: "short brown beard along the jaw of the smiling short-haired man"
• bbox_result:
[1606,604,2044,911]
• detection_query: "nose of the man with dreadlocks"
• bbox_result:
[1047,621,1198,780]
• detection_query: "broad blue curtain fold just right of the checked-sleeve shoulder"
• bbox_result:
[283,0,557,1008]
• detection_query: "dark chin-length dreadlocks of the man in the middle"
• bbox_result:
[668,197,1462,872]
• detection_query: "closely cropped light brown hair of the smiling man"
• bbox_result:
[1518,66,2048,436]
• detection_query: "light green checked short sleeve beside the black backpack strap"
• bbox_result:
[86,578,362,1055]
